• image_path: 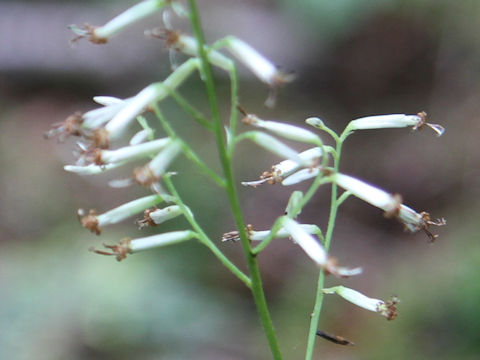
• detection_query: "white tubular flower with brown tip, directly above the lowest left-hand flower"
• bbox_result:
[78,195,163,235]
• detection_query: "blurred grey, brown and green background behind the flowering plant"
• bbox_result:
[0,0,480,360]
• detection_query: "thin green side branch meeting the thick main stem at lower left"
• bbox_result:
[163,176,252,288]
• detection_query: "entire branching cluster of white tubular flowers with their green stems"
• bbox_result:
[45,0,446,354]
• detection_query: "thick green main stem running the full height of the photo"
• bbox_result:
[189,0,282,360]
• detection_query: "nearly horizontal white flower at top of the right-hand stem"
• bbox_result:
[347,111,445,136]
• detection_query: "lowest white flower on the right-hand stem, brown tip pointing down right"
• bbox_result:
[322,286,398,320]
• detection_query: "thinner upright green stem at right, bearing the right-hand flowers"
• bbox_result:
[305,139,346,360]
